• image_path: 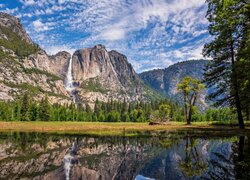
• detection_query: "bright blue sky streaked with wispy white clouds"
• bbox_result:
[0,0,209,73]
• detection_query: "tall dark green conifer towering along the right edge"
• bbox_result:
[203,0,250,128]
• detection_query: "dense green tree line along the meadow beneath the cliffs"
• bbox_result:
[0,93,238,122]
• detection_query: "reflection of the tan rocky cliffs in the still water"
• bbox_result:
[0,136,162,179]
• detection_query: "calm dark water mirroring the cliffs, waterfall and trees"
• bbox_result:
[0,133,250,180]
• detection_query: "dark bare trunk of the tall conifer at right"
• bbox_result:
[231,45,245,129]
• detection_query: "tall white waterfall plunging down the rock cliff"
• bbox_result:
[65,56,76,102]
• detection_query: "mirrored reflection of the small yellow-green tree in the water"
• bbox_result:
[179,137,208,177]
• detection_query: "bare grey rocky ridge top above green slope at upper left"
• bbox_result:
[0,12,33,44]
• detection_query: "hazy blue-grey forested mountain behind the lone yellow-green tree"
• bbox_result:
[139,60,209,107]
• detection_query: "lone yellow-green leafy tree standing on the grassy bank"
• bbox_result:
[177,77,205,124]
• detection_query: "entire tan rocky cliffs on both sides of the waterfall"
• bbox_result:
[0,12,158,104]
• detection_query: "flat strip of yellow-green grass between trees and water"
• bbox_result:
[0,121,250,136]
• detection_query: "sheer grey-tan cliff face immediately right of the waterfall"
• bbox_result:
[72,45,155,105]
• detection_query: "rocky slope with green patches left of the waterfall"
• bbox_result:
[0,13,70,104]
